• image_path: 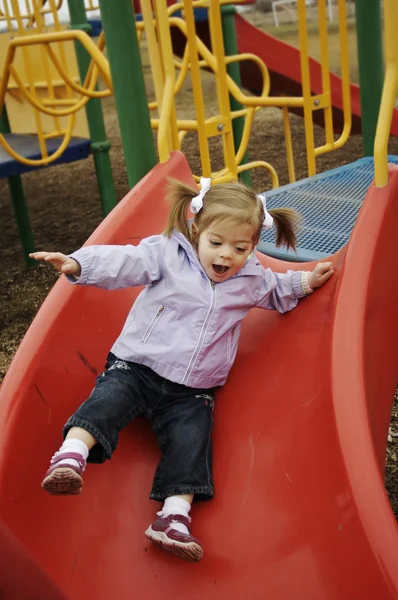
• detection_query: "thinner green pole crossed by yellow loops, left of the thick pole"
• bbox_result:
[68,0,117,216]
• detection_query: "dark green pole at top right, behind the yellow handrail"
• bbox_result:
[355,0,384,156]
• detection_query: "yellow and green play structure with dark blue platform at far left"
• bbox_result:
[0,0,116,264]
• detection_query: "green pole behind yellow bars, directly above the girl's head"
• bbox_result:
[221,4,251,185]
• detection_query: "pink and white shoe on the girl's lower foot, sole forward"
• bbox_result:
[145,515,203,562]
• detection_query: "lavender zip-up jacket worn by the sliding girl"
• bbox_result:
[68,232,305,388]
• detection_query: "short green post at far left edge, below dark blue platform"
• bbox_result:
[0,105,37,267]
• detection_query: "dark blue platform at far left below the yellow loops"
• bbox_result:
[0,133,91,179]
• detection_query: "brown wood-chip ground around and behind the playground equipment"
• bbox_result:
[0,5,398,517]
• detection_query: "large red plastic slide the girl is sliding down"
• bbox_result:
[0,152,398,600]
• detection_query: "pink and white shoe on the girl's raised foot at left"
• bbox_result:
[41,452,86,496]
